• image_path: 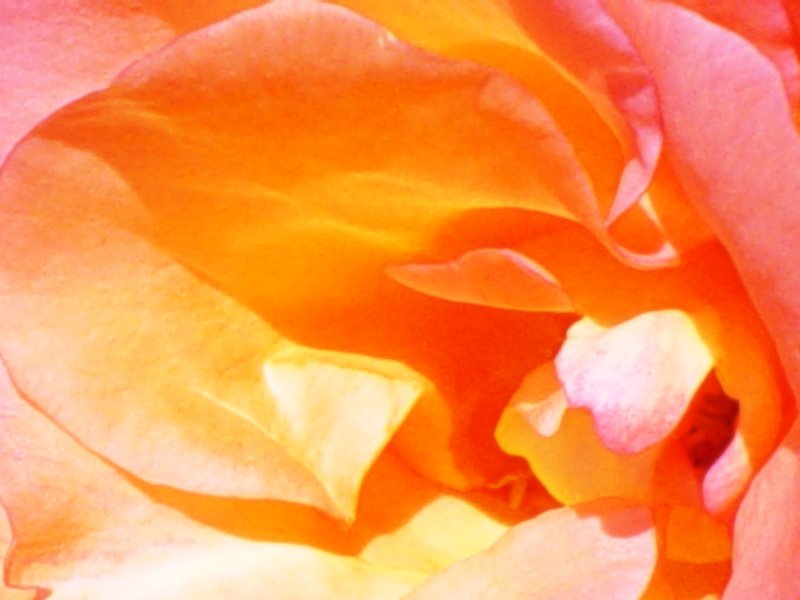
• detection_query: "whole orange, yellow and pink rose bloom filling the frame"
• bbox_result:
[0,3,795,597]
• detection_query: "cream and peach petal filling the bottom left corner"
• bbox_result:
[0,358,422,600]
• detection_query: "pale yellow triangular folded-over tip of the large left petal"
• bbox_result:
[264,346,424,518]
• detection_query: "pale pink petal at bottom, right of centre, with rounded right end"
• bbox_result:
[409,503,657,600]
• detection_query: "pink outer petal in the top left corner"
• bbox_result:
[0,0,260,164]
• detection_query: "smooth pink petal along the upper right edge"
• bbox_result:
[609,0,800,406]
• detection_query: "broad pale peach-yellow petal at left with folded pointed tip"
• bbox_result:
[0,134,438,517]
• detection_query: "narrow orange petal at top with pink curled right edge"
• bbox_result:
[336,0,676,267]
